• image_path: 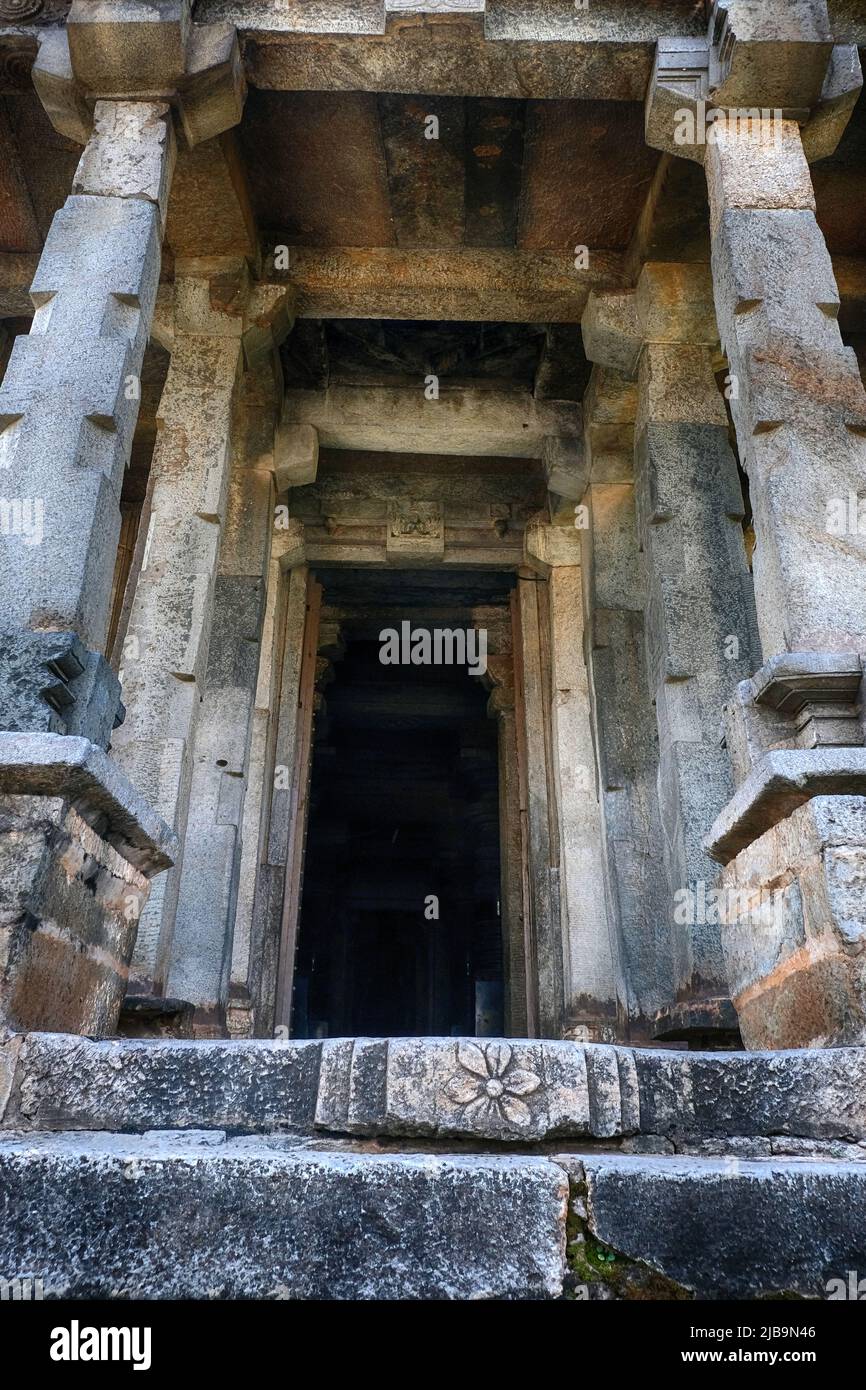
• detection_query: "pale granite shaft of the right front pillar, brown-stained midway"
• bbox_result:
[708,122,866,659]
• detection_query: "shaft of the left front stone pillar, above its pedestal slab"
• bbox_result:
[0,101,174,746]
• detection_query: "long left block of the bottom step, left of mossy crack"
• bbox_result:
[0,1133,569,1300]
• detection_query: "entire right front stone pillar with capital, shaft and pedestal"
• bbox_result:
[646,0,866,1048]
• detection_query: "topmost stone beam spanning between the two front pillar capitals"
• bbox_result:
[196,0,701,101]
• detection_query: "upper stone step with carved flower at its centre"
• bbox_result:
[0,1033,866,1158]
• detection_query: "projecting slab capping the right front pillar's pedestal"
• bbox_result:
[705,748,866,865]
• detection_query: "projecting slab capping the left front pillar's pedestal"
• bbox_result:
[0,733,178,877]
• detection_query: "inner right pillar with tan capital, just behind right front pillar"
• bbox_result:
[584,263,755,1037]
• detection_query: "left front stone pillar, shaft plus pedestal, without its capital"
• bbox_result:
[0,101,177,1033]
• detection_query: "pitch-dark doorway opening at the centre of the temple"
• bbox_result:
[292,571,507,1037]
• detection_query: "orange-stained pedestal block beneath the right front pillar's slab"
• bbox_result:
[721,796,866,1048]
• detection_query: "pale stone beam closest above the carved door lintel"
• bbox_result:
[282,381,582,459]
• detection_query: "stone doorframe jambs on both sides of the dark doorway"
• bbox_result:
[228,521,619,1040]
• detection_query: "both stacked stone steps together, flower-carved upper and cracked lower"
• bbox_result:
[0,1033,866,1301]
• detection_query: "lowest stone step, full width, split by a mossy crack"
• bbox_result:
[0,1130,866,1300]
